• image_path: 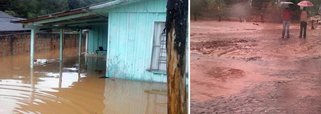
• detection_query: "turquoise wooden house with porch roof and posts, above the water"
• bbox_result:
[19,0,167,82]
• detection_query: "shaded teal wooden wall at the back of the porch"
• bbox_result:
[88,22,108,54]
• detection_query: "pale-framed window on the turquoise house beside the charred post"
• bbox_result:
[151,22,167,72]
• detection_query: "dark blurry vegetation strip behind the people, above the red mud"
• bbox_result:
[191,0,321,21]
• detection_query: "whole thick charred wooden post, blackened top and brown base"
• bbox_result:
[166,0,188,114]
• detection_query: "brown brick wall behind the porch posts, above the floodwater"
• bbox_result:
[0,32,79,56]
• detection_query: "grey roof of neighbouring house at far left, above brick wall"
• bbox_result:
[0,11,30,33]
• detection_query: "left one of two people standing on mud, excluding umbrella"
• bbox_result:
[282,7,292,38]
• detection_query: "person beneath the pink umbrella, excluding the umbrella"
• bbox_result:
[300,7,308,38]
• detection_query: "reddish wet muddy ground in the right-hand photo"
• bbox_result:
[191,21,321,114]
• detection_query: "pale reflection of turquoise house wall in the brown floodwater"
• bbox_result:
[104,80,167,114]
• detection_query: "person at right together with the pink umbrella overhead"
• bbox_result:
[298,0,313,39]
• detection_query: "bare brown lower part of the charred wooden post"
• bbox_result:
[167,28,187,114]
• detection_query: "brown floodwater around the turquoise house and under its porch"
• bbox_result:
[0,49,167,114]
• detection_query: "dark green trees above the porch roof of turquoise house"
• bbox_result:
[0,0,110,18]
